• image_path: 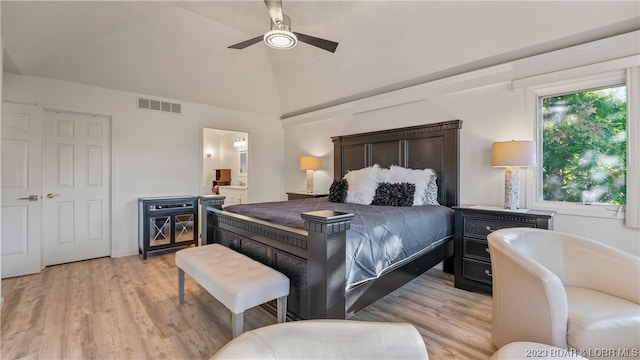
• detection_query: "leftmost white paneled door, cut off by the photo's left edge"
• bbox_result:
[0,103,43,278]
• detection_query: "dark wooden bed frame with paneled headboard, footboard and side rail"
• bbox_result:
[203,120,462,319]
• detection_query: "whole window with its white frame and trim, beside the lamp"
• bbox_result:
[512,64,640,222]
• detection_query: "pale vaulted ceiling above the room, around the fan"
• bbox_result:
[0,0,640,117]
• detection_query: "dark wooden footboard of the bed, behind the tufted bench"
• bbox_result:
[206,207,353,319]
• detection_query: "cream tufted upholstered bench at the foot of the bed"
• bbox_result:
[176,244,289,337]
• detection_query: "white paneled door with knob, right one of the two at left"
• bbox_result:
[42,111,111,266]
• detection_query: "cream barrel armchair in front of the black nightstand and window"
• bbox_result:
[488,228,640,359]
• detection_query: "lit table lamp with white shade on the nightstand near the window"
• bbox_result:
[491,140,536,210]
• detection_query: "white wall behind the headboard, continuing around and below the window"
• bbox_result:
[283,33,640,255]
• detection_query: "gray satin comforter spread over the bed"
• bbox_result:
[225,197,453,290]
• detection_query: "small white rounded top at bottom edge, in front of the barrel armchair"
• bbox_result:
[489,341,586,360]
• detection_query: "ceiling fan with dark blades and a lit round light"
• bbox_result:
[228,0,338,53]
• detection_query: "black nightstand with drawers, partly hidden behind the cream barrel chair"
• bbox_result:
[454,205,555,293]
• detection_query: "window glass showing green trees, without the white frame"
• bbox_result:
[538,84,627,205]
